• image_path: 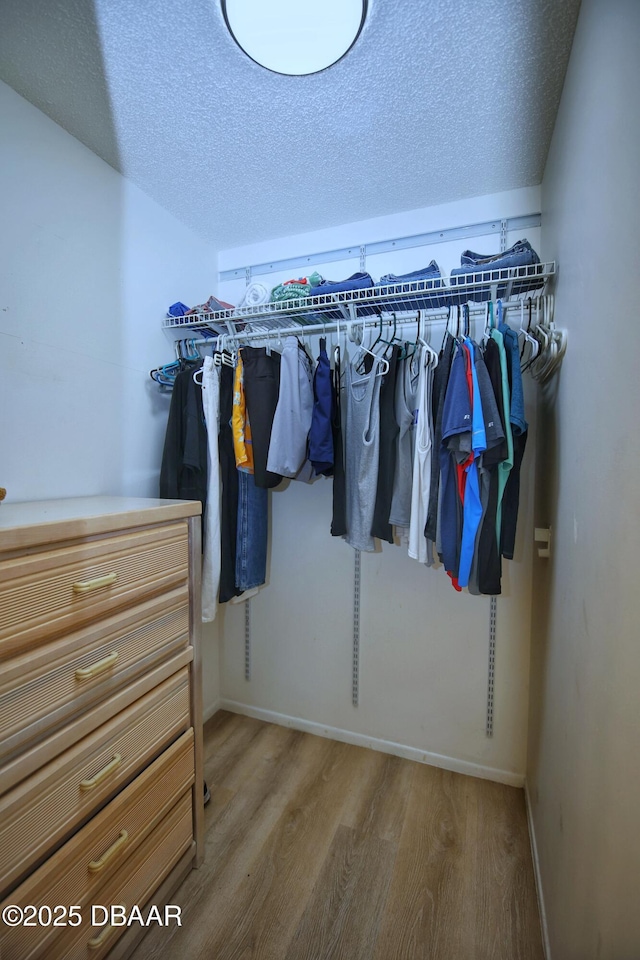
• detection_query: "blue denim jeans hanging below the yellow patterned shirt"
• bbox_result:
[236,470,269,592]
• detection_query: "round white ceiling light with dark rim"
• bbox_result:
[221,0,367,76]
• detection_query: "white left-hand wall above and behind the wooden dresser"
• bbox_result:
[0,83,218,706]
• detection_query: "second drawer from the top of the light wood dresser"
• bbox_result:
[0,584,189,761]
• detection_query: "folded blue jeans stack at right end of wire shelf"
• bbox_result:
[449,240,544,304]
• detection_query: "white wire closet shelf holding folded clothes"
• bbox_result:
[163,262,555,342]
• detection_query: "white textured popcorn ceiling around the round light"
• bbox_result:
[0,0,579,248]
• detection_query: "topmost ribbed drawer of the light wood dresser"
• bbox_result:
[0,521,188,659]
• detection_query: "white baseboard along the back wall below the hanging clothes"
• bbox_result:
[219,697,524,787]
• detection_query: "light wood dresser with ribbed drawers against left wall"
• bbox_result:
[0,497,204,960]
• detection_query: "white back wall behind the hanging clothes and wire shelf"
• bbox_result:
[219,189,540,784]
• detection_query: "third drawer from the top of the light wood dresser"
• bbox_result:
[0,667,189,894]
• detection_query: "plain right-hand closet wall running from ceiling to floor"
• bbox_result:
[528,0,640,960]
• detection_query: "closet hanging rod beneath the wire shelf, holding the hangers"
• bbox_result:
[185,300,536,347]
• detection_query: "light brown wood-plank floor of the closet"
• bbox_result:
[133,711,543,960]
